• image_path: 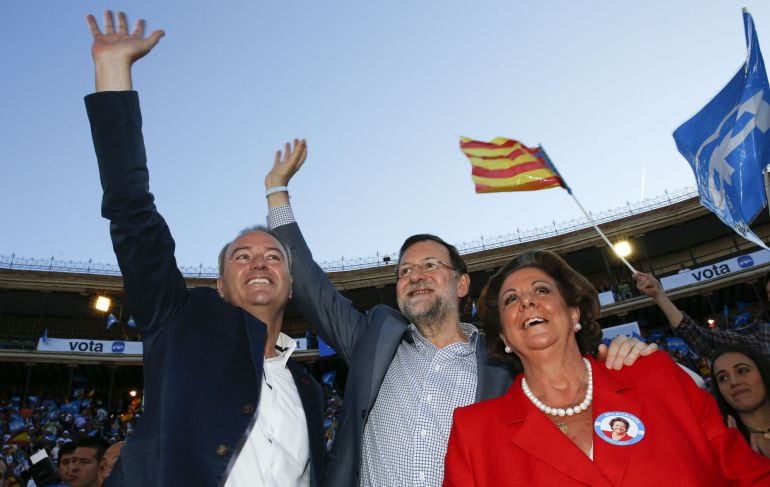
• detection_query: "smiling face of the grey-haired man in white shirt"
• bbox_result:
[217,231,292,310]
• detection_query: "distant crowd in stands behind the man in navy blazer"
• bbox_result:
[0,371,342,487]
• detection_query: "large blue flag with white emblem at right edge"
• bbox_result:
[674,9,770,250]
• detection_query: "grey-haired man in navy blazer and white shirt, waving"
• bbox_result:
[86,12,324,487]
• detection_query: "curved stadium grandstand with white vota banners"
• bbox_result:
[0,189,770,468]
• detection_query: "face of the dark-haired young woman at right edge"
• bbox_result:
[713,352,768,413]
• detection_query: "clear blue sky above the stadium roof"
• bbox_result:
[0,0,770,266]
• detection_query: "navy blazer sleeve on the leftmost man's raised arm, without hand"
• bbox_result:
[85,91,188,335]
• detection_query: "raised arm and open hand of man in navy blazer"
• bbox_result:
[85,11,187,336]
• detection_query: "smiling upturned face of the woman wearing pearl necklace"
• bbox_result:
[498,267,580,358]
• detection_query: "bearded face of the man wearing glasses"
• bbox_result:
[396,240,470,327]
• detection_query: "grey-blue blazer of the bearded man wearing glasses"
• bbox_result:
[274,223,513,487]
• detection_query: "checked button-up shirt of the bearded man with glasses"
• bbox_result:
[361,323,479,487]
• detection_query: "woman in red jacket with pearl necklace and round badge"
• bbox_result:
[444,251,770,487]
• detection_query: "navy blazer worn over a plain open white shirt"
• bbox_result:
[86,91,325,487]
